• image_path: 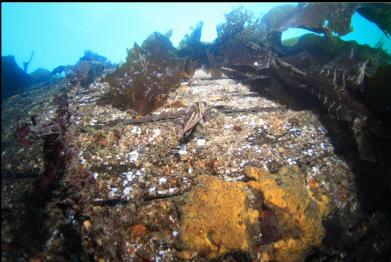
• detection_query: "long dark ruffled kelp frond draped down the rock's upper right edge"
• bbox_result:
[222,53,382,161]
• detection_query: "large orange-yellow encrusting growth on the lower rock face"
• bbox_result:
[179,167,329,261]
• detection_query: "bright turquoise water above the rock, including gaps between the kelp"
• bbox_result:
[1,3,391,72]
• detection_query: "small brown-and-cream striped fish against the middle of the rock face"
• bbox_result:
[182,102,208,138]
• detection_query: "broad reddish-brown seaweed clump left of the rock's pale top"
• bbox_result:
[105,32,192,114]
